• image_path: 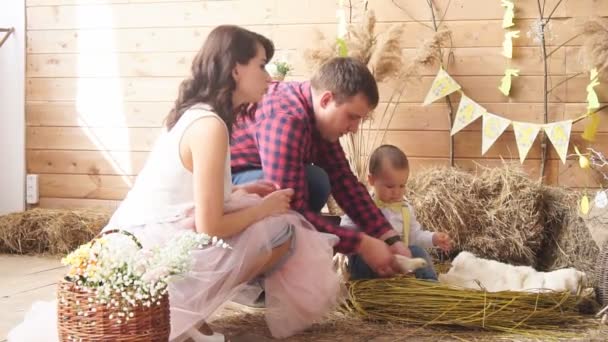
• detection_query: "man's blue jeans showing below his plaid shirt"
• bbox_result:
[232,164,331,212]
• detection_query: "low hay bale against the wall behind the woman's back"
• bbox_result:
[0,208,111,255]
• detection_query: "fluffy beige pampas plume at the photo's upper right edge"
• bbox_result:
[581,18,608,79]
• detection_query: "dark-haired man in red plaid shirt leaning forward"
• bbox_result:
[231,58,411,284]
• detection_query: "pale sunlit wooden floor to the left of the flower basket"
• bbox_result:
[0,254,65,341]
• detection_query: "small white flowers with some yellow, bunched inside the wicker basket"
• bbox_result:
[63,232,230,322]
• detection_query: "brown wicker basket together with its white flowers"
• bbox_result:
[57,230,229,341]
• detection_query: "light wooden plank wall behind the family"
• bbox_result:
[26,0,608,207]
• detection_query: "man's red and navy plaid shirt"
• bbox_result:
[230,82,391,253]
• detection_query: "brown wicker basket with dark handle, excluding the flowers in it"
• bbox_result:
[57,231,171,342]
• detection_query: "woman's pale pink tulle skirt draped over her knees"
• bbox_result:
[117,195,340,339]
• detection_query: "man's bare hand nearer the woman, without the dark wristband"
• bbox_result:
[357,234,398,277]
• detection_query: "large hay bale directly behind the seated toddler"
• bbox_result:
[408,164,544,265]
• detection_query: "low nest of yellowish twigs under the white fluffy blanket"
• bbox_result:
[348,277,597,338]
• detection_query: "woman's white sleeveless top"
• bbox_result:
[106,104,232,229]
